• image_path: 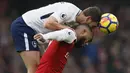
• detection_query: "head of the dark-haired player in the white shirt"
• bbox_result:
[77,6,102,28]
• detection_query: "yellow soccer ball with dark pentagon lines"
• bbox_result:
[99,13,119,34]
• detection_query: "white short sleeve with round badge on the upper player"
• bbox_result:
[51,4,81,23]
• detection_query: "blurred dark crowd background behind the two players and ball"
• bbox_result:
[0,0,130,73]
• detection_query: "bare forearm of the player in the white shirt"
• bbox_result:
[44,22,69,30]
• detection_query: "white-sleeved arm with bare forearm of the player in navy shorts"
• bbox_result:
[43,5,81,30]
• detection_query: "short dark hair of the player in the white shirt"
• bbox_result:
[83,6,102,22]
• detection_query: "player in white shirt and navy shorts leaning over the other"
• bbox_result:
[11,2,101,73]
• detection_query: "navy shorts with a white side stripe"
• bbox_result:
[11,17,39,52]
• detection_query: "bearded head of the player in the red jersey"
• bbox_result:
[72,24,93,47]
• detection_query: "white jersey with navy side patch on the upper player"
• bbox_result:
[22,2,81,33]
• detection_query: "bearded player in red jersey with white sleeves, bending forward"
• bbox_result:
[34,25,93,73]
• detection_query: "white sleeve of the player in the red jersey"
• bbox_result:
[42,28,77,43]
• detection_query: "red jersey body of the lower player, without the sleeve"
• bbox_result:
[36,40,74,73]
